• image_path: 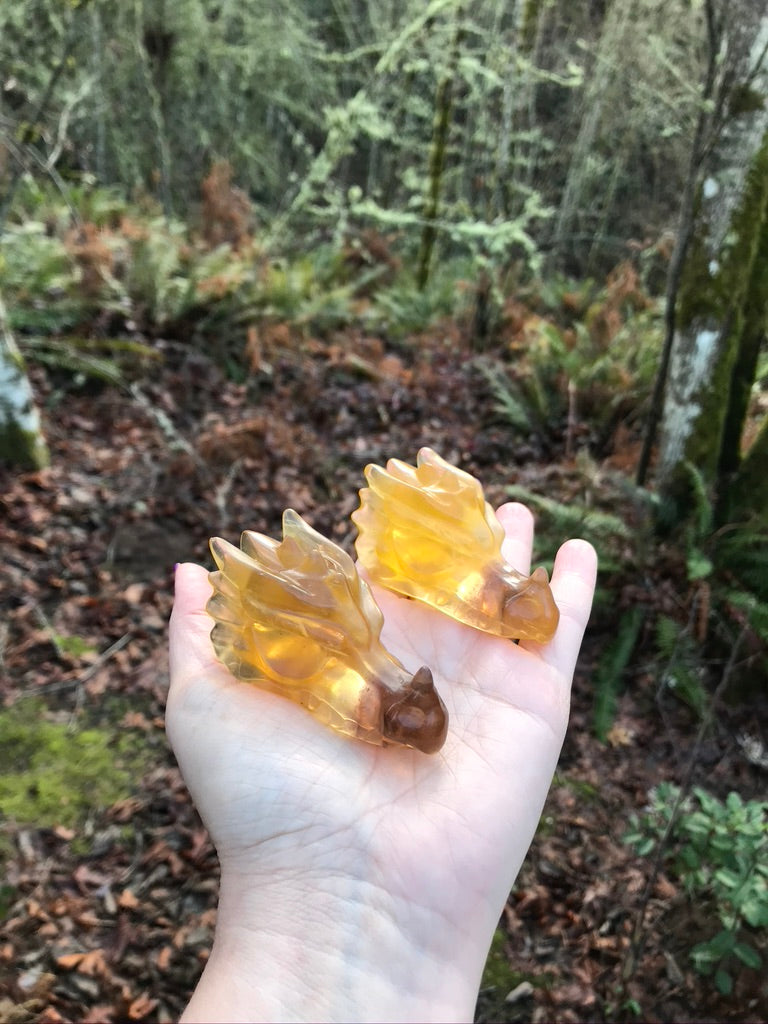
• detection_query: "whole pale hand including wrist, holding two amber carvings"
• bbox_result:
[167,504,596,1020]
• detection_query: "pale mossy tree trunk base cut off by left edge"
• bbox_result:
[0,296,49,469]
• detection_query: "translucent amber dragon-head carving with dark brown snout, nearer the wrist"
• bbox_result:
[208,509,447,754]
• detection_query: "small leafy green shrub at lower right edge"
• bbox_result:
[624,782,768,995]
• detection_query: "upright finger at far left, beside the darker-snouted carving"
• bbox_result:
[169,562,215,686]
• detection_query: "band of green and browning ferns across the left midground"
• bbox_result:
[0,182,481,385]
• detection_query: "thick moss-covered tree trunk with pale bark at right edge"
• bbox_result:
[656,13,768,520]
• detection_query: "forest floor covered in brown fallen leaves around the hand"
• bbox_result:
[0,321,768,1022]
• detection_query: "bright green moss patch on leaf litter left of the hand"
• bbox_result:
[0,699,150,827]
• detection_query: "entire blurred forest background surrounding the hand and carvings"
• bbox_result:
[0,0,768,1021]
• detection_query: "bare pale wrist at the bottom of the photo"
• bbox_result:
[183,870,486,1022]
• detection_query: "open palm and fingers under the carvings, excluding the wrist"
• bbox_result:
[167,504,595,1016]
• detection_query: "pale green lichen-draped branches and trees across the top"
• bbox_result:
[0,0,716,270]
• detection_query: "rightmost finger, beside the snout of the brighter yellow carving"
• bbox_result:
[520,541,597,679]
